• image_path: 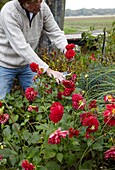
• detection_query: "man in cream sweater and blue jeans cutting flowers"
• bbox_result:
[0,0,67,99]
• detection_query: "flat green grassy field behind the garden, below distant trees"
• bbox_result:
[64,15,115,34]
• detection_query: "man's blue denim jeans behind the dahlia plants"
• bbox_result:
[0,65,36,99]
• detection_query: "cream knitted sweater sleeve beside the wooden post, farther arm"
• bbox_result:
[44,2,68,52]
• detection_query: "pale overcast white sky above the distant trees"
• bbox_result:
[66,0,115,10]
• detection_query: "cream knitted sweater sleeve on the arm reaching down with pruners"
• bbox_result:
[1,6,49,72]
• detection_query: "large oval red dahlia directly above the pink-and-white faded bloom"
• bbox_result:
[49,102,64,123]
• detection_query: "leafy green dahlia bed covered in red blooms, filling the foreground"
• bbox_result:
[0,45,115,170]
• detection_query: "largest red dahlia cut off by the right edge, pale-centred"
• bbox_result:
[103,104,115,126]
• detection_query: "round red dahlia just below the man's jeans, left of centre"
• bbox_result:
[25,87,38,101]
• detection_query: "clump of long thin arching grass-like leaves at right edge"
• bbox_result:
[79,65,115,100]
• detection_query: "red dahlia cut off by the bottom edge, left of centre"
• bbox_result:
[21,160,35,170]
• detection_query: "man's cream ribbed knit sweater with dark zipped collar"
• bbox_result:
[0,0,67,72]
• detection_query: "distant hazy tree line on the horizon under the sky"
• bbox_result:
[65,8,115,16]
